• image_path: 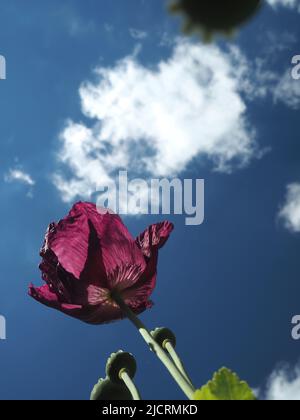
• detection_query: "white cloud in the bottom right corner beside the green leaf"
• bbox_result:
[264,360,300,401]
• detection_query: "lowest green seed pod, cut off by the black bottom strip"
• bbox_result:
[90,378,132,401]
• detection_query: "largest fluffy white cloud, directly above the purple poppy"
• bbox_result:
[54,41,256,201]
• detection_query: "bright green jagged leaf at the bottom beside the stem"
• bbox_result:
[194,368,256,401]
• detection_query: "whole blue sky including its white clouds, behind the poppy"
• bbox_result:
[0,0,300,399]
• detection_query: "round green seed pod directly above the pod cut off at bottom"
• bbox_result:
[106,350,137,384]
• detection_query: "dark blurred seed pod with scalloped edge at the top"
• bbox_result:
[169,0,262,40]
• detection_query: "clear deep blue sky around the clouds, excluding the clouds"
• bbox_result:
[0,0,300,399]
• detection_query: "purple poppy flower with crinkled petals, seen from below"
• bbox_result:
[29,203,173,324]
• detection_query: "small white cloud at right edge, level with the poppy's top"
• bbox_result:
[279,183,300,233]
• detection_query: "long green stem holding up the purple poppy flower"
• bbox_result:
[112,293,195,400]
